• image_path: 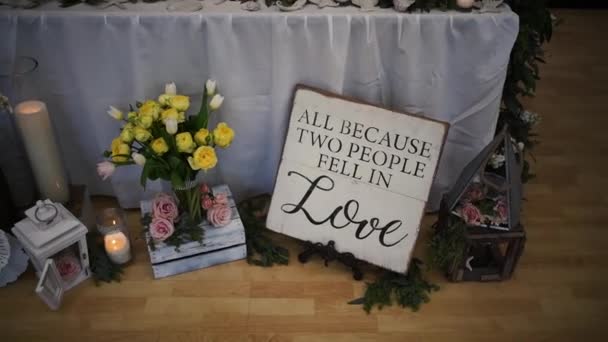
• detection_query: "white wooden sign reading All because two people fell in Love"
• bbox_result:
[266,86,448,272]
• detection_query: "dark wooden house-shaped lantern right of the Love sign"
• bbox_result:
[437,128,526,281]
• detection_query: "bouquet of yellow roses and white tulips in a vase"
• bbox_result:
[97,80,234,223]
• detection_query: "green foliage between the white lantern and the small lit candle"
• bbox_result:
[87,231,123,286]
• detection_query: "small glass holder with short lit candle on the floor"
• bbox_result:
[97,208,133,265]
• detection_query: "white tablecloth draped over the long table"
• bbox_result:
[0,1,518,207]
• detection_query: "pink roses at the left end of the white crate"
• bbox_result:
[149,192,179,241]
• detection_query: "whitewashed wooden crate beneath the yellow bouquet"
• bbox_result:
[140,185,247,279]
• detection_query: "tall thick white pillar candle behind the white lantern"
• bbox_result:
[15,101,69,203]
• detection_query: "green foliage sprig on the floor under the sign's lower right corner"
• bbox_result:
[349,258,439,313]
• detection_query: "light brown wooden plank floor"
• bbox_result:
[0,11,608,342]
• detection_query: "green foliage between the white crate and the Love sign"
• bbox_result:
[237,194,289,267]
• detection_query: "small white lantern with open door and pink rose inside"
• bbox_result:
[12,200,91,310]
